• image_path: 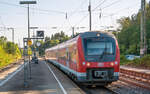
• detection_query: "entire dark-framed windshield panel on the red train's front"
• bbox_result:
[83,37,115,62]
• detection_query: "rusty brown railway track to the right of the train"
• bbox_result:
[119,68,150,90]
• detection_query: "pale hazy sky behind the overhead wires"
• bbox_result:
[0,0,146,46]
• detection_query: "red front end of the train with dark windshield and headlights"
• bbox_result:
[78,32,120,85]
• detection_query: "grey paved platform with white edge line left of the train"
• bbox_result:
[0,61,83,94]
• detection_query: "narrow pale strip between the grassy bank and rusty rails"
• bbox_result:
[120,66,150,75]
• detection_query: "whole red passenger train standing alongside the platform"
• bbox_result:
[45,31,120,86]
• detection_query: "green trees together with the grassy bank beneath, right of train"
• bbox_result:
[115,3,150,69]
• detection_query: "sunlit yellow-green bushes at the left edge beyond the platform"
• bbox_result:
[0,36,21,68]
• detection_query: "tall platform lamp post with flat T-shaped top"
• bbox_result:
[19,1,36,79]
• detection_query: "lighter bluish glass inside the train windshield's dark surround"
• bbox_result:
[86,42,113,55]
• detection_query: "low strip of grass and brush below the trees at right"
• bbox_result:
[120,55,150,69]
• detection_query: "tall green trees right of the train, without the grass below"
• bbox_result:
[115,1,150,55]
